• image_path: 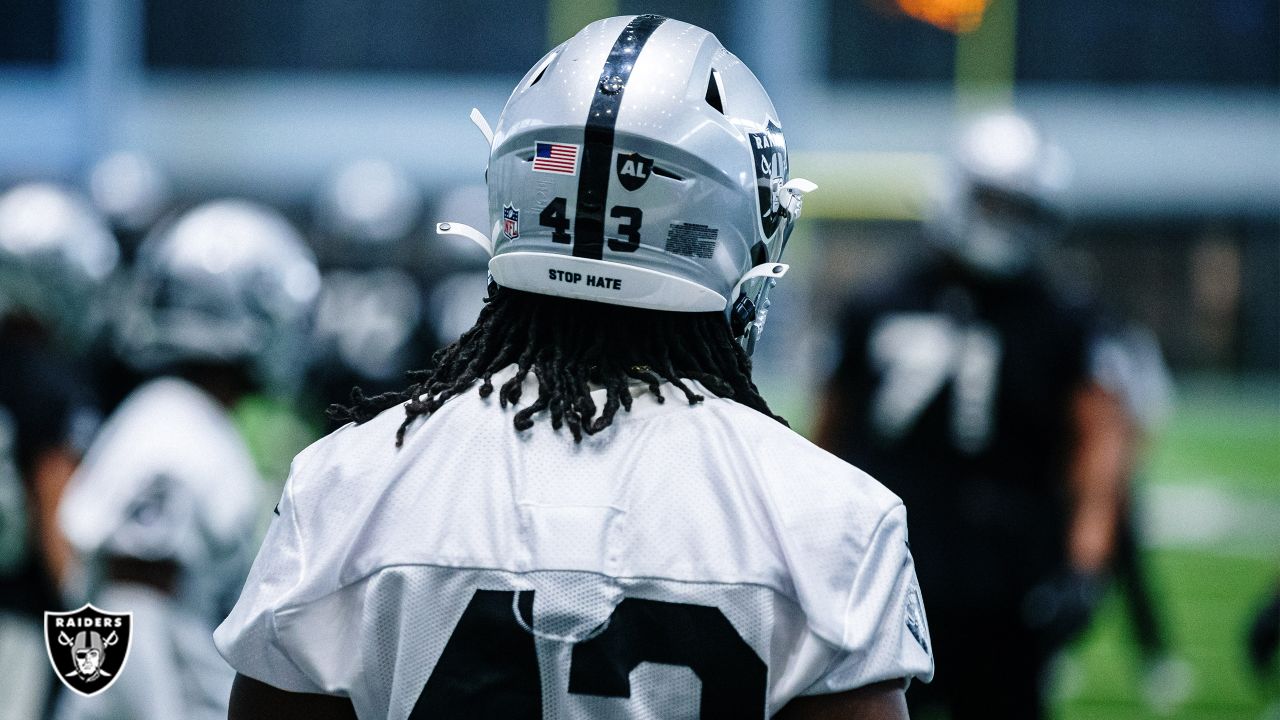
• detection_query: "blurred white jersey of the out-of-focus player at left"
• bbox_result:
[59,378,269,624]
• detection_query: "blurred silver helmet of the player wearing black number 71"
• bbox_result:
[925,113,1071,277]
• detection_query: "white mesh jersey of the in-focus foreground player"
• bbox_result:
[214,370,933,720]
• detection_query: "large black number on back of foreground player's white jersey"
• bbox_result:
[410,591,768,720]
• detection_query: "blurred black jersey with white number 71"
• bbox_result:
[831,254,1093,607]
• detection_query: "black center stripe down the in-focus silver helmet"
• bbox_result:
[573,15,667,260]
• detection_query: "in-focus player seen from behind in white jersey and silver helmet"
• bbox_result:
[215,15,933,719]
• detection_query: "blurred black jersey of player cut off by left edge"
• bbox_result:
[0,327,101,616]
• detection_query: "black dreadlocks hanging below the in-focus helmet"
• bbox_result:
[329,287,786,447]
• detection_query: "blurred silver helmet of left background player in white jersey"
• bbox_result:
[118,200,320,389]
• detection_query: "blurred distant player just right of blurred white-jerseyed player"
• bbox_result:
[307,159,438,414]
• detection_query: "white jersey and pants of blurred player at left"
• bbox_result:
[59,378,261,720]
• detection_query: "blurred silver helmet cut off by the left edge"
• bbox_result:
[0,182,119,342]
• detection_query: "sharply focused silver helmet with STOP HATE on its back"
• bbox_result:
[440,15,814,345]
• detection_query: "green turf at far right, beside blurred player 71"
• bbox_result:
[1055,378,1280,720]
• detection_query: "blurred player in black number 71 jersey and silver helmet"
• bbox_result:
[818,114,1128,720]
